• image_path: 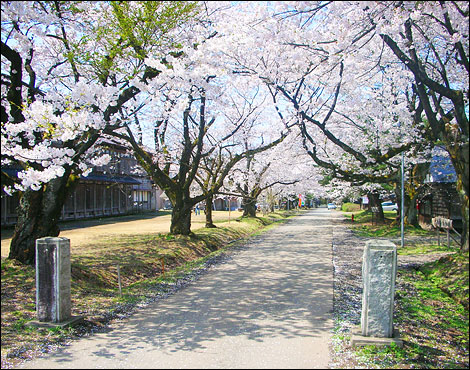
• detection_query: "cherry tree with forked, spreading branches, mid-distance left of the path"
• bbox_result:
[114,70,286,235]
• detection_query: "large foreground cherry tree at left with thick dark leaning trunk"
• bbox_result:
[1,1,195,263]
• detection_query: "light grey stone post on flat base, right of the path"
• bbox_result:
[351,240,403,347]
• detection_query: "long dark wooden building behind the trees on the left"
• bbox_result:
[1,140,164,226]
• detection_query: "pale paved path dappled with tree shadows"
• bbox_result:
[22,209,341,369]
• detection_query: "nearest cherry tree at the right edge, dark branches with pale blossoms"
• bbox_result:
[274,1,470,250]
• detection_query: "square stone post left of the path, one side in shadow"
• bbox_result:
[36,237,71,323]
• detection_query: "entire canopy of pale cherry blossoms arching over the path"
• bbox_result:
[1,1,470,260]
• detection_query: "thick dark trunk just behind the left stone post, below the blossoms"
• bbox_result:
[8,175,78,265]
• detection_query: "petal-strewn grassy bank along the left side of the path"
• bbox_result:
[1,211,295,368]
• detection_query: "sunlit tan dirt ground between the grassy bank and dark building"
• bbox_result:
[1,211,242,258]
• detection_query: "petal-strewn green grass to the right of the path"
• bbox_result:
[338,204,469,369]
